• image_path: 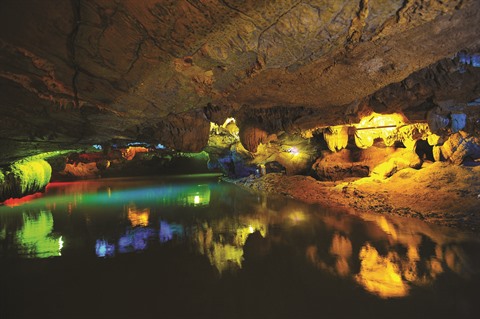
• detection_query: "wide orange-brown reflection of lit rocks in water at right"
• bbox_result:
[306,215,474,298]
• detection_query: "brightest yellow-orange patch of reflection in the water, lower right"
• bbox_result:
[355,244,408,298]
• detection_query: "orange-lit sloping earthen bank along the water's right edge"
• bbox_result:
[227,162,480,234]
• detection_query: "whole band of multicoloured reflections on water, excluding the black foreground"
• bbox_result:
[0,175,480,298]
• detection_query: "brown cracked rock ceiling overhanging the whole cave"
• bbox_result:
[0,0,480,163]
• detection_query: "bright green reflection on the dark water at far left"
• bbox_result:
[17,211,63,258]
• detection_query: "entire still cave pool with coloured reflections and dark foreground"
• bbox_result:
[0,176,480,318]
